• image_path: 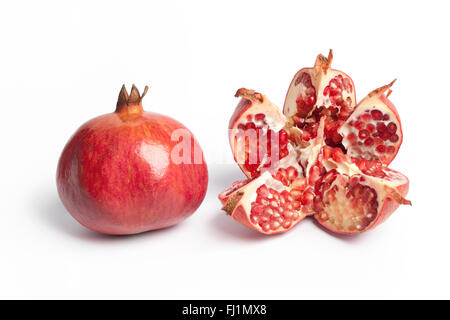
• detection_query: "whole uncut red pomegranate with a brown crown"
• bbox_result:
[57,85,208,234]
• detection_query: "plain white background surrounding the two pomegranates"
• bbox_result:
[0,0,450,299]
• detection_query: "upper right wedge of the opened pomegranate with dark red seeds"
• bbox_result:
[338,84,402,163]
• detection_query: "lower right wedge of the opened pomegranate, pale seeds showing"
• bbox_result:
[314,146,411,234]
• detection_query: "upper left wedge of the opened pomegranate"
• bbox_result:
[229,95,288,178]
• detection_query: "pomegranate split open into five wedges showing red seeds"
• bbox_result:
[219,50,410,234]
